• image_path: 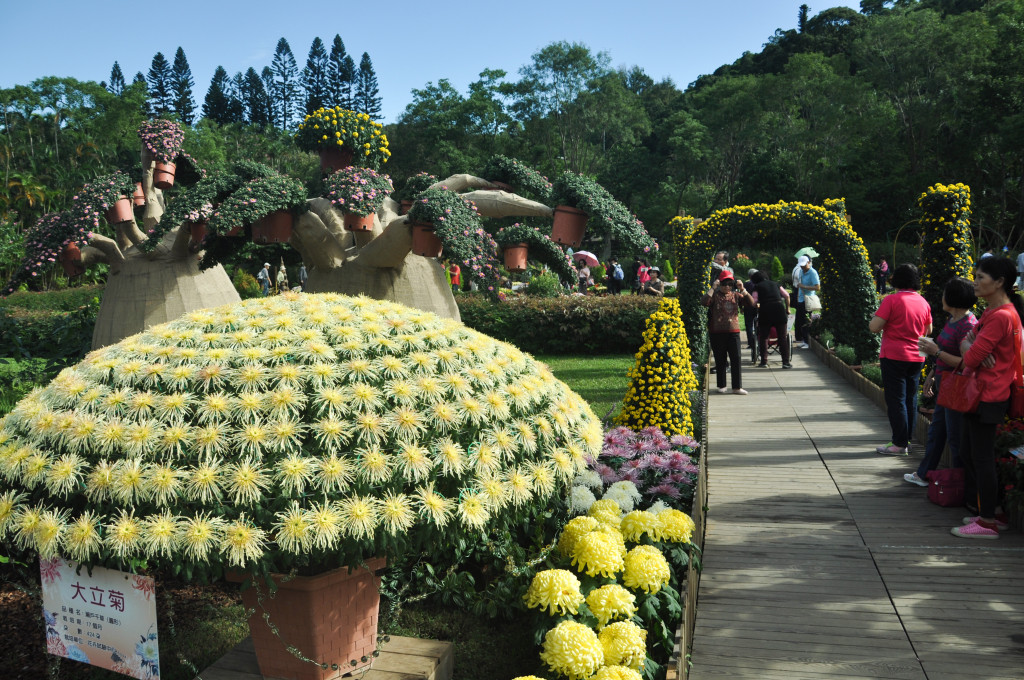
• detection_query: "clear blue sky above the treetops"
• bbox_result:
[0,0,860,123]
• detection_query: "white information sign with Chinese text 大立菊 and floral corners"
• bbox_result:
[39,557,160,680]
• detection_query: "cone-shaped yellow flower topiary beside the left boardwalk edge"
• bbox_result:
[615,298,697,436]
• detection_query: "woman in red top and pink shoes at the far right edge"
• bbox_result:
[952,257,1024,539]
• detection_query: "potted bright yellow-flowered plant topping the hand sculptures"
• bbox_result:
[295,107,391,174]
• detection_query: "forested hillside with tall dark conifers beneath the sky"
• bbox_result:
[0,0,1024,284]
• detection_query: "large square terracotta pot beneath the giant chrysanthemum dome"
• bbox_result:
[229,557,386,680]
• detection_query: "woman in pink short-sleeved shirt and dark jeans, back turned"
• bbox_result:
[867,264,932,456]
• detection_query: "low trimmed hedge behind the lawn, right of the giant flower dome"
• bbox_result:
[456,295,660,354]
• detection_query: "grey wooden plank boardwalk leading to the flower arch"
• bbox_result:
[689,349,1024,680]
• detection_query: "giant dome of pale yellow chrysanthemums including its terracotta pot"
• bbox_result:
[0,294,602,680]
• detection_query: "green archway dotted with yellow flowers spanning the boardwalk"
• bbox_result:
[673,199,880,362]
